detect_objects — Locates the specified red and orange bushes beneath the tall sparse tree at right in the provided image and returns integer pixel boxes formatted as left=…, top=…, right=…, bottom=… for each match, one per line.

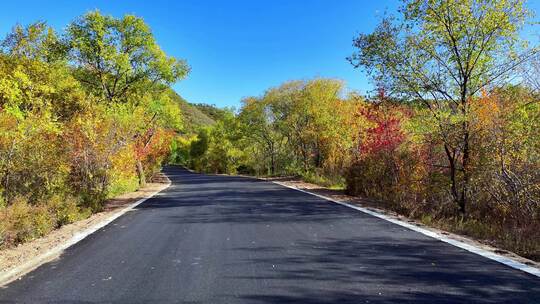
left=346, top=94, right=540, bottom=259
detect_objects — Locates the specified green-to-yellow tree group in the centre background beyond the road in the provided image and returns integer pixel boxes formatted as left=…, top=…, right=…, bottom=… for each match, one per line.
left=178, top=79, right=358, bottom=180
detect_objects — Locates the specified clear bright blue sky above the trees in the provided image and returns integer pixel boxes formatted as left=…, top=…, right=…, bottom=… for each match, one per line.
left=0, top=0, right=540, bottom=107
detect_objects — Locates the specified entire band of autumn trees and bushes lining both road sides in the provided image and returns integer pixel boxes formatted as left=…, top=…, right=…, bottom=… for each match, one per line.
left=0, top=0, right=540, bottom=258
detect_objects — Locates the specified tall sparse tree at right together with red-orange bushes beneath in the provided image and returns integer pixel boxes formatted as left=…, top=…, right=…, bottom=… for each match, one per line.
left=347, top=0, right=540, bottom=259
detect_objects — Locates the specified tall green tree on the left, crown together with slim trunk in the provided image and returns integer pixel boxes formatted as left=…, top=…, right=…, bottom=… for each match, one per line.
left=67, top=11, right=189, bottom=185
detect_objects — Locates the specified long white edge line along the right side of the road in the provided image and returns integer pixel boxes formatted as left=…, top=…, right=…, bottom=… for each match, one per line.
left=272, top=181, right=540, bottom=278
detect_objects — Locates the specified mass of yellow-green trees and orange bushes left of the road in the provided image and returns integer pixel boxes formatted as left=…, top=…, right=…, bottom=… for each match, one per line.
left=0, top=11, right=189, bottom=247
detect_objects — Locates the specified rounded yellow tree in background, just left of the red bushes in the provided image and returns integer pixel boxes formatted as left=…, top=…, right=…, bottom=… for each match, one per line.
left=263, top=78, right=355, bottom=173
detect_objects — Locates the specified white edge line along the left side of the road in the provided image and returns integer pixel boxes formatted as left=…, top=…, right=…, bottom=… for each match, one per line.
left=0, top=181, right=171, bottom=287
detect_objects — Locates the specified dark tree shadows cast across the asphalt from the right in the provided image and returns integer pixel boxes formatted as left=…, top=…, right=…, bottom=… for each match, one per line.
left=140, top=167, right=540, bottom=304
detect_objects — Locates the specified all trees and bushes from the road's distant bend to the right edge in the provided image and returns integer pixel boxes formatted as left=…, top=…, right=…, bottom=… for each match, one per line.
left=172, top=0, right=540, bottom=260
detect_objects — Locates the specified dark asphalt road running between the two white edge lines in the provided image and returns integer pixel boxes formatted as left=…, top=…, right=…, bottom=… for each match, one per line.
left=0, top=167, right=540, bottom=304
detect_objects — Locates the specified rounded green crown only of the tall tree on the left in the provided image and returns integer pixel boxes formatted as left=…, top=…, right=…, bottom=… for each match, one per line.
left=67, top=11, right=189, bottom=102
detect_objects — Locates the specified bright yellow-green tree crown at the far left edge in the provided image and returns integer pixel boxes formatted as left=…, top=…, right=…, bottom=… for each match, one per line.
left=0, top=22, right=84, bottom=121
